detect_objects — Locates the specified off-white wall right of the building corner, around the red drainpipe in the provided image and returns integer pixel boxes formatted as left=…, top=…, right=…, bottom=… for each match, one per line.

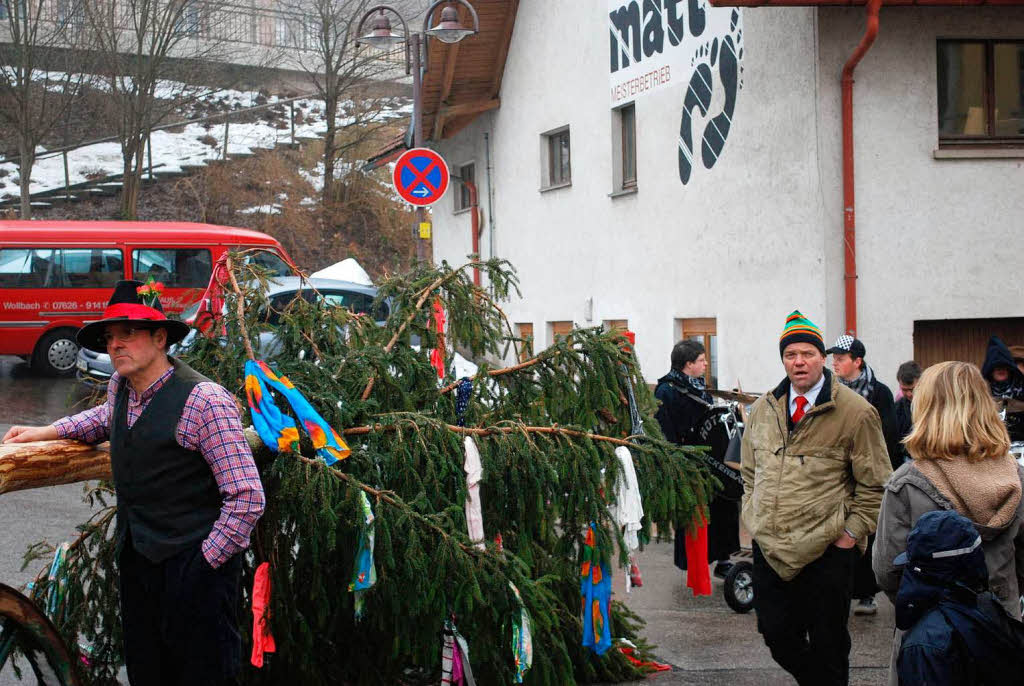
left=819, top=7, right=1024, bottom=386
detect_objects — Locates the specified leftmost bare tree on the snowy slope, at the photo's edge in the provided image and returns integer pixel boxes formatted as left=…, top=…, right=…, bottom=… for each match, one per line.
left=0, top=0, right=87, bottom=219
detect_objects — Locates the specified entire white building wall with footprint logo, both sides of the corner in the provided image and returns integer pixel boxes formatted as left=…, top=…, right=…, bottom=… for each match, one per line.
left=434, top=2, right=1024, bottom=391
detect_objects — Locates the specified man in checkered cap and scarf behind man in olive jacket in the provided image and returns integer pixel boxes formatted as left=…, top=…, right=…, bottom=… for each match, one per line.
left=825, top=334, right=903, bottom=614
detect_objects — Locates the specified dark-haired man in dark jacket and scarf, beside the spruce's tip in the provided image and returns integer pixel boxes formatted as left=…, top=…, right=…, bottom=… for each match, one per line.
left=654, top=340, right=739, bottom=577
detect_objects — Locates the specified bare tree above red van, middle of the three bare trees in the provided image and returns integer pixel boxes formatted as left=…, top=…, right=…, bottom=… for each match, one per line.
left=82, top=0, right=270, bottom=219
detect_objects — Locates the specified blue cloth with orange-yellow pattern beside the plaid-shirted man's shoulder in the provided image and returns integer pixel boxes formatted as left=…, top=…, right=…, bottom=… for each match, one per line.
left=246, top=359, right=351, bottom=467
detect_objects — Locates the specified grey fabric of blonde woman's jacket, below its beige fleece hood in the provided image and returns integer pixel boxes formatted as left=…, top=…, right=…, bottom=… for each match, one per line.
left=871, top=462, right=1024, bottom=618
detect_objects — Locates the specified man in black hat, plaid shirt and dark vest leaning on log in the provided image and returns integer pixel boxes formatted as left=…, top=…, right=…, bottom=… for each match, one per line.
left=3, top=280, right=265, bottom=686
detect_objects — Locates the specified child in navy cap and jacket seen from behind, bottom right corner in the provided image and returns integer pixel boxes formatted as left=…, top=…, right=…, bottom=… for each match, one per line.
left=893, top=510, right=1024, bottom=686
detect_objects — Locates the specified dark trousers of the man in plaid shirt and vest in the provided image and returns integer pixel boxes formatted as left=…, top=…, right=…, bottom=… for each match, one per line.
left=119, top=538, right=242, bottom=686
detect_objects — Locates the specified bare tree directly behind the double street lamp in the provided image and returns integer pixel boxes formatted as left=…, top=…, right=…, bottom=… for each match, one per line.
left=285, top=0, right=411, bottom=205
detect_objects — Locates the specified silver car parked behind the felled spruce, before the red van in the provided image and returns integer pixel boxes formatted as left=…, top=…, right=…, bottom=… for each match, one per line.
left=76, top=276, right=390, bottom=386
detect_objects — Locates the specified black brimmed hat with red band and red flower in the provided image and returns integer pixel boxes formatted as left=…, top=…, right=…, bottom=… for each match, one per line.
left=76, top=280, right=188, bottom=352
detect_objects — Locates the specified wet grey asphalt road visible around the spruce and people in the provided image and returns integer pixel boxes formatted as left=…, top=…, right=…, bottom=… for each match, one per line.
left=0, top=356, right=894, bottom=686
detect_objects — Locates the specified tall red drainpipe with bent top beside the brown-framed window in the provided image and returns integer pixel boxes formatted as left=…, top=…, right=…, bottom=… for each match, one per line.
left=842, top=0, right=882, bottom=336
